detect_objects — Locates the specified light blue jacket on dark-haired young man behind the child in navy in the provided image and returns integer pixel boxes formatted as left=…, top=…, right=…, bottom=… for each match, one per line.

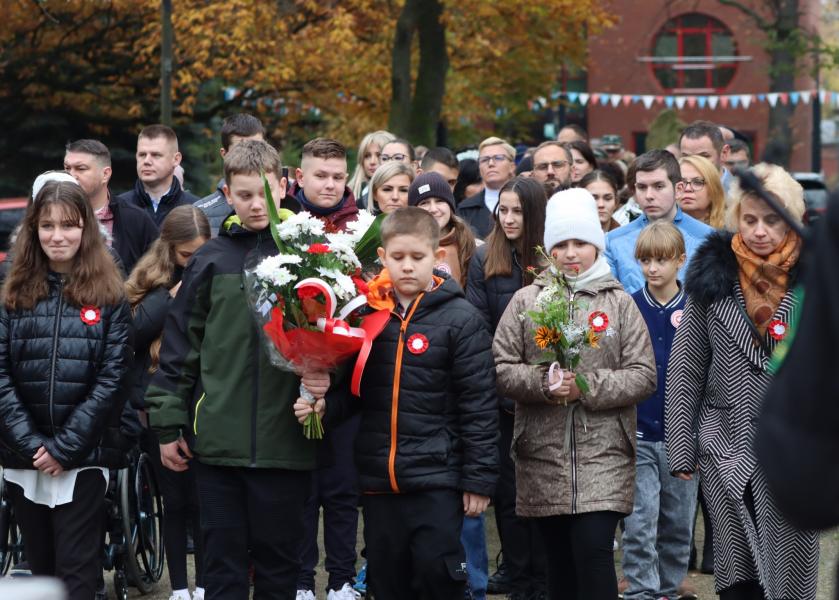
left=606, top=206, right=714, bottom=294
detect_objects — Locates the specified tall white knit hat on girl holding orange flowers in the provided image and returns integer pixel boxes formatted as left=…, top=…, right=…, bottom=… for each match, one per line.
left=545, top=188, right=606, bottom=252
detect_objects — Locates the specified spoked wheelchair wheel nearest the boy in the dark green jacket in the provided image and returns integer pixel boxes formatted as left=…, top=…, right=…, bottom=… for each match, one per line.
left=118, top=453, right=163, bottom=594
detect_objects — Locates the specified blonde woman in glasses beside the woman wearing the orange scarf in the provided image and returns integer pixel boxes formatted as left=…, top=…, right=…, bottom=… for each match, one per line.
left=679, top=155, right=725, bottom=229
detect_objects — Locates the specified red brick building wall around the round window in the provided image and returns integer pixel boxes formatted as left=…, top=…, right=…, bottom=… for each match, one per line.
left=587, top=0, right=818, bottom=171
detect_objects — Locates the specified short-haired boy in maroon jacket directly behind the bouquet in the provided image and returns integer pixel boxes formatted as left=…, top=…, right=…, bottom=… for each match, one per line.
left=283, top=138, right=358, bottom=230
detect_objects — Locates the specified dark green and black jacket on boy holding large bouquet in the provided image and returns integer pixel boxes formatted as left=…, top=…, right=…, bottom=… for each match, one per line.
left=146, top=217, right=317, bottom=470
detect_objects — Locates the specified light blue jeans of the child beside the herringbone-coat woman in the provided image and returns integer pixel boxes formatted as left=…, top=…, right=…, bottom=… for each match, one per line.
left=623, top=440, right=698, bottom=600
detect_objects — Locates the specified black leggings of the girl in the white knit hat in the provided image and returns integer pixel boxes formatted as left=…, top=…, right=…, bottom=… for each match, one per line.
left=536, top=511, right=622, bottom=600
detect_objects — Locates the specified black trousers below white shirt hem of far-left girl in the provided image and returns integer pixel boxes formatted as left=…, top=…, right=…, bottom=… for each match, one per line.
left=6, top=470, right=105, bottom=600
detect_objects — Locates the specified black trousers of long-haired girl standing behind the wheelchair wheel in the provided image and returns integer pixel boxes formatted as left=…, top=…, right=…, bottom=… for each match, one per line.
left=148, top=430, right=204, bottom=590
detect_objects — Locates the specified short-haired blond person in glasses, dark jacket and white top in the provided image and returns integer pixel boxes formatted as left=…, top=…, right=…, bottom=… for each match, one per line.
left=457, top=137, right=516, bottom=239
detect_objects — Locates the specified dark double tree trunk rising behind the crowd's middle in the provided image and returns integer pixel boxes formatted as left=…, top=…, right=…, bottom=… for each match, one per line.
left=389, top=0, right=449, bottom=146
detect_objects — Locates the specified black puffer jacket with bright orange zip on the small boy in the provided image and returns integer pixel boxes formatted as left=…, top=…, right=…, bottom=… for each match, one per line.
left=327, top=279, right=498, bottom=496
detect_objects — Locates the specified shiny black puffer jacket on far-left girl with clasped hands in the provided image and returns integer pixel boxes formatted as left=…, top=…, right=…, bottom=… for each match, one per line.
left=0, top=274, right=132, bottom=469
